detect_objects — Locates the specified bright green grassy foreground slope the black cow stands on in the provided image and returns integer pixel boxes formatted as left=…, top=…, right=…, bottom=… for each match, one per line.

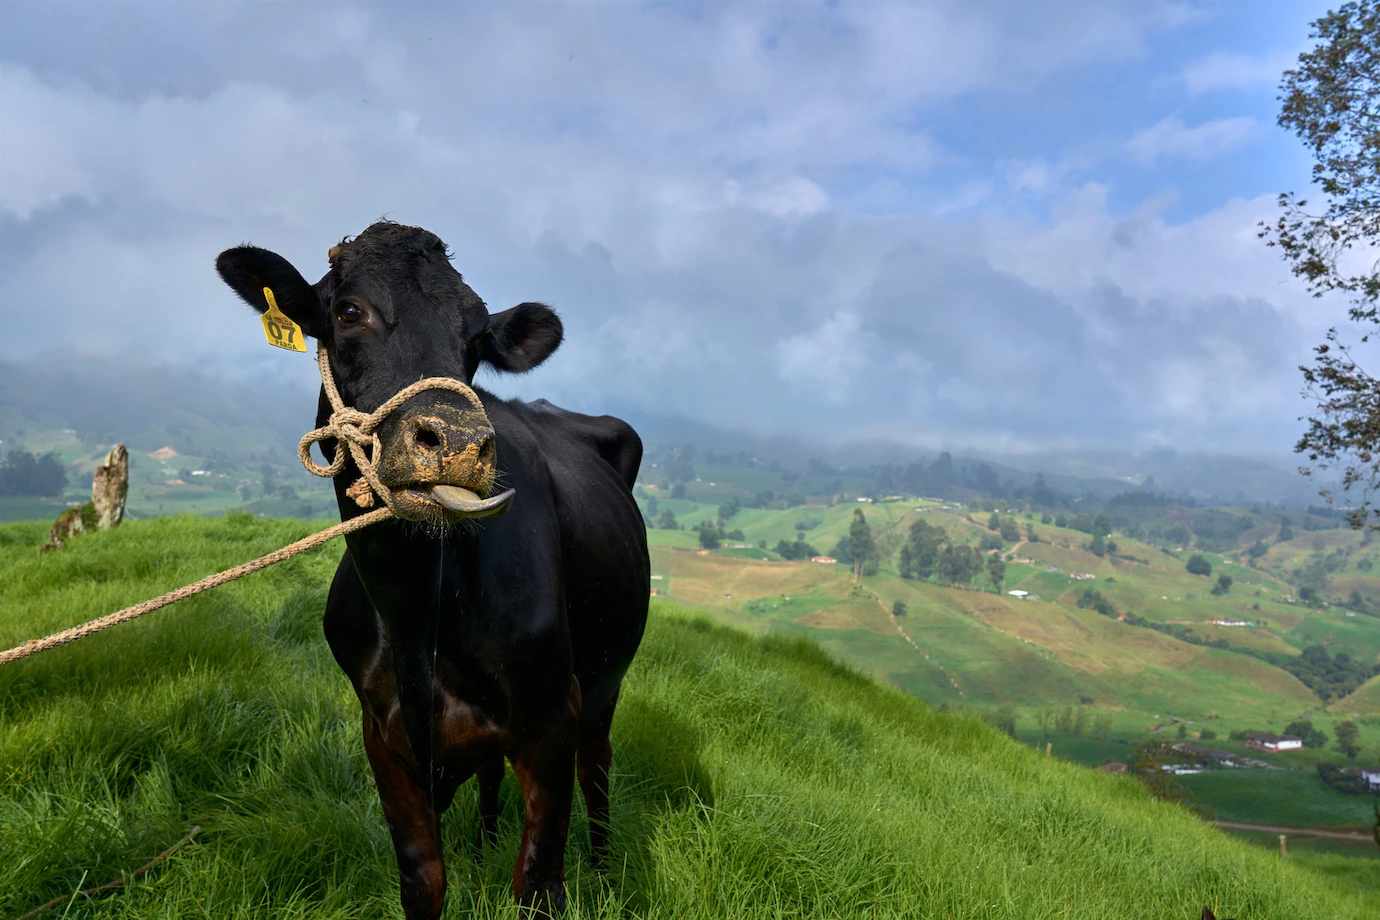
left=0, top=517, right=1373, bottom=920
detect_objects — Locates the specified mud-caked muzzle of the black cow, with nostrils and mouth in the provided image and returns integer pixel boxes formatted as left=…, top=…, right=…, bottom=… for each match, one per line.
left=378, top=393, right=498, bottom=520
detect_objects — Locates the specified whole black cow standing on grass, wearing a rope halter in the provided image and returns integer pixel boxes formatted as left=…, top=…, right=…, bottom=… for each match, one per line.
left=217, top=222, right=651, bottom=919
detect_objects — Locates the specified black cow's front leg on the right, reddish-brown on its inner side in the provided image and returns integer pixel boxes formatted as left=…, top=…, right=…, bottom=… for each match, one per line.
left=511, top=677, right=580, bottom=914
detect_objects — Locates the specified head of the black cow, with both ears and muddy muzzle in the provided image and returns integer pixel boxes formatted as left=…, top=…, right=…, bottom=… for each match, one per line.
left=215, top=222, right=562, bottom=521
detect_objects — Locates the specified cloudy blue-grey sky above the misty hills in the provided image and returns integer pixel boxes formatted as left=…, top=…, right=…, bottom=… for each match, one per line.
left=0, top=0, right=1346, bottom=457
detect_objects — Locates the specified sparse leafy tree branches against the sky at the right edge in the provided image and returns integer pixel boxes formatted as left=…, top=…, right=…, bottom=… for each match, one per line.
left=1260, top=0, right=1380, bottom=527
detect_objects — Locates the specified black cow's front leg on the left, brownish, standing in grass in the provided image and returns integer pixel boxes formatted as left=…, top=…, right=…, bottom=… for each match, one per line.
left=364, top=710, right=446, bottom=920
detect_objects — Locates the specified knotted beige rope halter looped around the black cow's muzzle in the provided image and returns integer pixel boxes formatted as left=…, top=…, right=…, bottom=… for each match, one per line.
left=297, top=345, right=484, bottom=512
